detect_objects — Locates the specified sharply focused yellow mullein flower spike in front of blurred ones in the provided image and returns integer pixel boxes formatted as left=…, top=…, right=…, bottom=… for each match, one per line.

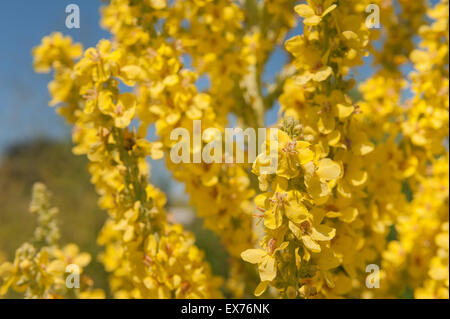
left=246, top=1, right=374, bottom=298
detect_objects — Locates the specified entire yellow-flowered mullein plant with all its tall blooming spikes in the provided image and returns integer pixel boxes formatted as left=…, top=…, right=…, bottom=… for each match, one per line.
left=1, top=0, right=449, bottom=298
